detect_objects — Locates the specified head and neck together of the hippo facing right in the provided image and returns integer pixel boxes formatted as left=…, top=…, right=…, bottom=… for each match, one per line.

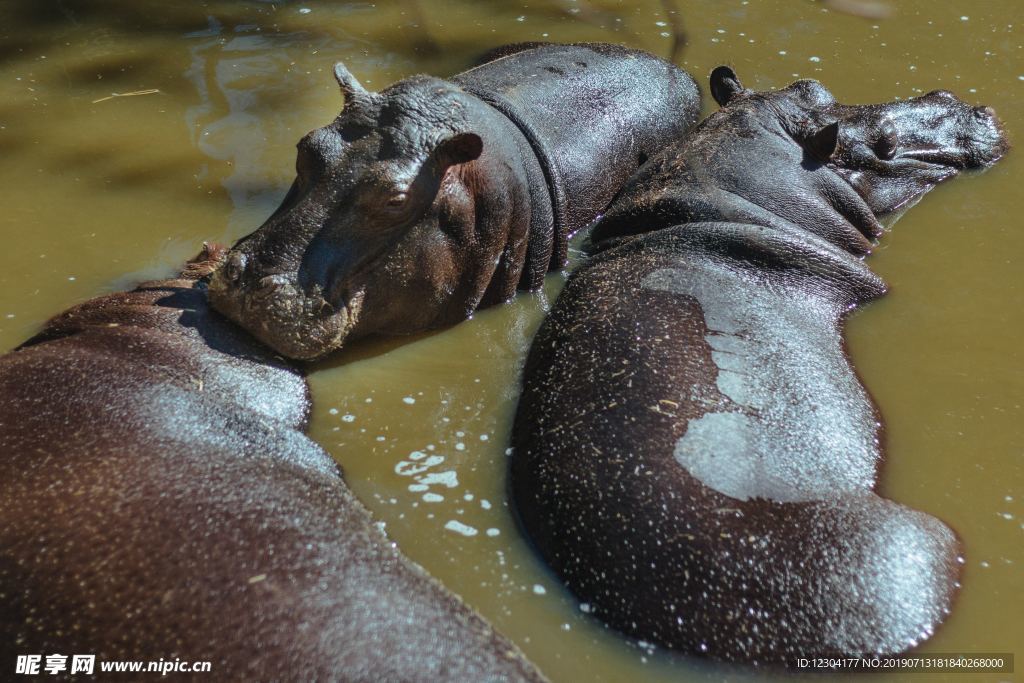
left=591, top=67, right=1009, bottom=255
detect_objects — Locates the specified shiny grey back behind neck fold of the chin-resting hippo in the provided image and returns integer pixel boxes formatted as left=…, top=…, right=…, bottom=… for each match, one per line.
left=452, top=43, right=700, bottom=267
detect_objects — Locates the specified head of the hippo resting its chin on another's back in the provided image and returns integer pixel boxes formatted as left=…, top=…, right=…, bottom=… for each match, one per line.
left=209, top=63, right=512, bottom=359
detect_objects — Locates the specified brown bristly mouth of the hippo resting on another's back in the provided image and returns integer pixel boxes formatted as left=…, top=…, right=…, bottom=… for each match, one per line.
left=209, top=268, right=365, bottom=360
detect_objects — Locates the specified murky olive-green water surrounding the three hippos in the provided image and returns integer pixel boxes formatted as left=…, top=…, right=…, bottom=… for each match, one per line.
left=0, top=0, right=1024, bottom=681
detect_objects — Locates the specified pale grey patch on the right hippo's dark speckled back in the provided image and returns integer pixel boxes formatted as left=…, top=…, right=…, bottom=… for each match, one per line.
left=641, top=261, right=879, bottom=502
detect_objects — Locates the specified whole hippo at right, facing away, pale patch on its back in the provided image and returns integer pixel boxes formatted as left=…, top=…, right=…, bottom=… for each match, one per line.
left=510, top=67, right=1008, bottom=666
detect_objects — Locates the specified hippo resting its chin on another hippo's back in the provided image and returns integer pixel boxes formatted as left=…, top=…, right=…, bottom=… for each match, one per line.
left=210, top=43, right=700, bottom=360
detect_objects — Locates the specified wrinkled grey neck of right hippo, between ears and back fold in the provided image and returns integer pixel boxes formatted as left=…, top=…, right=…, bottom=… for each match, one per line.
left=591, top=105, right=882, bottom=257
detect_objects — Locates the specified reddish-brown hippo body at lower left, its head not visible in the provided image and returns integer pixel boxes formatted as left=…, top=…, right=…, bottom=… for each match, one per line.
left=0, top=244, right=544, bottom=681
